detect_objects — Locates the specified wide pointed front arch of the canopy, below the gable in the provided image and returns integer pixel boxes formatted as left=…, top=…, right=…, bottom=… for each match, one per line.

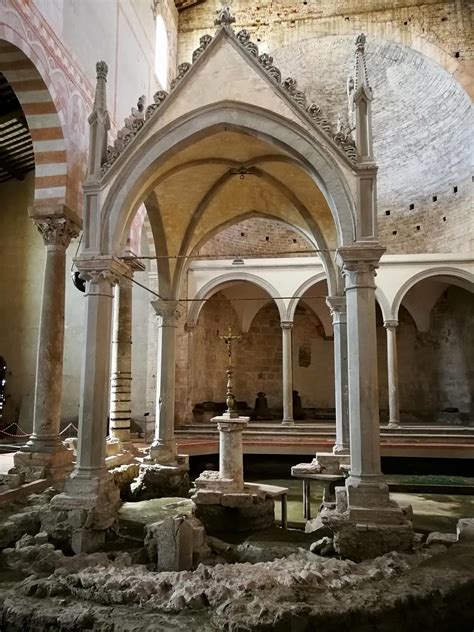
left=101, top=101, right=356, bottom=254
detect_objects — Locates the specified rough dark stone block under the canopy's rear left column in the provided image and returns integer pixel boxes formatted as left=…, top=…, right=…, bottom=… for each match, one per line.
left=130, top=454, right=190, bottom=501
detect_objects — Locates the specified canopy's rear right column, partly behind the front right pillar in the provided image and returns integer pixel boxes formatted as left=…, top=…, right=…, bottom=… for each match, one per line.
left=326, top=296, right=350, bottom=454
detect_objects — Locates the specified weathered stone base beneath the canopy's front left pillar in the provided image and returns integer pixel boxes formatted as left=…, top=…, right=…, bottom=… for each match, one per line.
left=41, top=470, right=121, bottom=553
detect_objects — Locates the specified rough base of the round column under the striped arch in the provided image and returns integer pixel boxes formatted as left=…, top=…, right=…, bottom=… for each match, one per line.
left=8, top=444, right=74, bottom=490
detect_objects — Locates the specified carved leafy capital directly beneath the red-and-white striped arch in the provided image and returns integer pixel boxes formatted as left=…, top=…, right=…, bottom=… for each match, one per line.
left=28, top=205, right=82, bottom=250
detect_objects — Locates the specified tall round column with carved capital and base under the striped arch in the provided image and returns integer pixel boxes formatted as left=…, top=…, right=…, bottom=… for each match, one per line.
left=15, top=206, right=81, bottom=478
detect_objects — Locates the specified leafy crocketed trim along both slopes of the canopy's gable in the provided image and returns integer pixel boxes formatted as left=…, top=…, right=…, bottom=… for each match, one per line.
left=101, top=6, right=365, bottom=175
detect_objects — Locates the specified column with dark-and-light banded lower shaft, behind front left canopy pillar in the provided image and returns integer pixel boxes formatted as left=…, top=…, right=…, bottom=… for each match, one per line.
left=109, top=261, right=144, bottom=442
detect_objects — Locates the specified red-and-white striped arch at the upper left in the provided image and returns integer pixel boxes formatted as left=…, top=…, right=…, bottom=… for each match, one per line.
left=0, top=38, right=67, bottom=206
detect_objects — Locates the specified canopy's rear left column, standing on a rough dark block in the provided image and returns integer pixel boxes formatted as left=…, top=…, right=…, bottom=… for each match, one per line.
left=150, top=299, right=181, bottom=465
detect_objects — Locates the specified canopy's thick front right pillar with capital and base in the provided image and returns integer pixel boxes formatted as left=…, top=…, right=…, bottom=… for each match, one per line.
left=337, top=244, right=397, bottom=522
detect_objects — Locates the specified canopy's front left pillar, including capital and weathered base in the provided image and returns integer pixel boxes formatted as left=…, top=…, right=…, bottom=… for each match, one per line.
left=49, top=256, right=127, bottom=553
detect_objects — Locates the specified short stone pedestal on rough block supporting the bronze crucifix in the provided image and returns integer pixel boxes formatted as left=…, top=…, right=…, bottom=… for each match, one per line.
left=191, top=413, right=275, bottom=533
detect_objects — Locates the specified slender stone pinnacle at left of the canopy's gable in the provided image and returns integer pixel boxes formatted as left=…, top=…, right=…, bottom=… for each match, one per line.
left=87, top=61, right=110, bottom=183
